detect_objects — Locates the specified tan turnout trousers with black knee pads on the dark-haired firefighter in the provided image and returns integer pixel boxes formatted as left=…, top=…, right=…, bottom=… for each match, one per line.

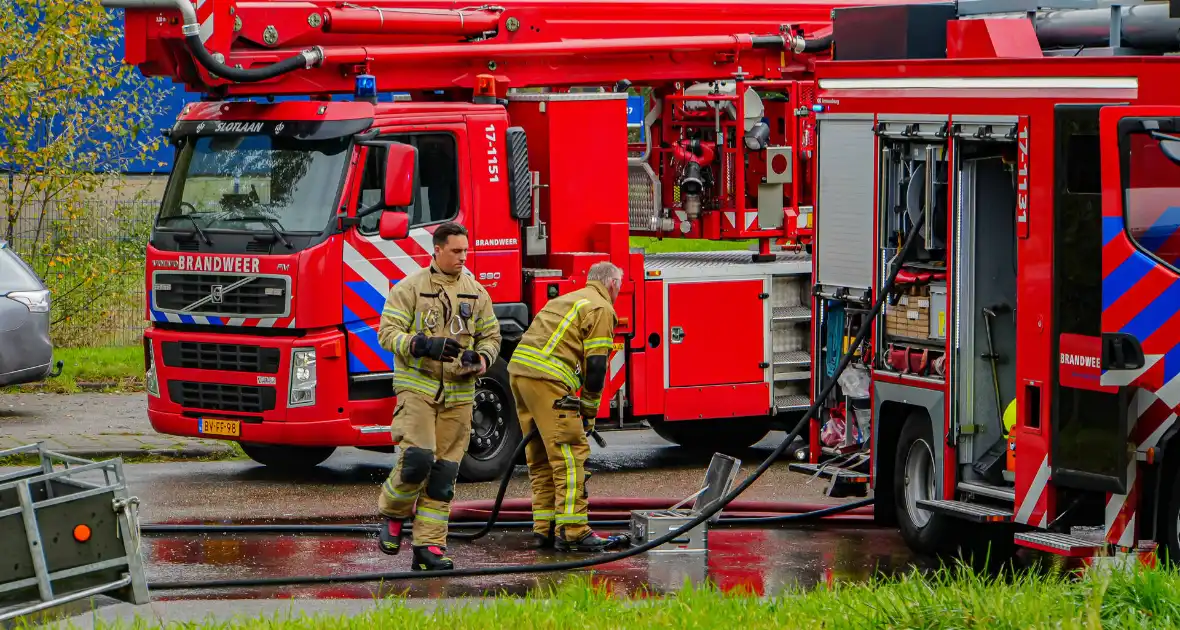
left=378, top=392, right=472, bottom=547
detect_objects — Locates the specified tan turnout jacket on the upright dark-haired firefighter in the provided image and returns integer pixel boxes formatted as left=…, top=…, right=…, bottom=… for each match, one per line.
left=378, top=262, right=500, bottom=408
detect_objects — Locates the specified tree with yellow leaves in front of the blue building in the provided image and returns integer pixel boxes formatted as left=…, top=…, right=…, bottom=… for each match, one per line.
left=0, top=0, right=162, bottom=346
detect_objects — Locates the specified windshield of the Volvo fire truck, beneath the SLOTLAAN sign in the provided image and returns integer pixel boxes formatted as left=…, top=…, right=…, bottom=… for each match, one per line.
left=158, top=134, right=348, bottom=234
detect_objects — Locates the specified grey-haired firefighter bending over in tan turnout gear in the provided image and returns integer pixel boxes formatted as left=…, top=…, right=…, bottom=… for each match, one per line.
left=509, top=262, right=623, bottom=551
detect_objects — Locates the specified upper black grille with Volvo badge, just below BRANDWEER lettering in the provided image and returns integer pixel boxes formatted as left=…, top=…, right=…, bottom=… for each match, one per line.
left=151, top=273, right=290, bottom=317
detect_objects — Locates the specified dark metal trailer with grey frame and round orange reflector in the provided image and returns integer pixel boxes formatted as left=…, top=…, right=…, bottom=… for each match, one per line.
left=0, top=444, right=149, bottom=621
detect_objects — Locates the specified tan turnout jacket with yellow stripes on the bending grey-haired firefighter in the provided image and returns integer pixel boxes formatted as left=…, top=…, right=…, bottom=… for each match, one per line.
left=509, top=281, right=618, bottom=405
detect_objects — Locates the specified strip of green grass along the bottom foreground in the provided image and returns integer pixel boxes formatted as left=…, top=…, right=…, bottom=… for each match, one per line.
left=39, top=567, right=1180, bottom=630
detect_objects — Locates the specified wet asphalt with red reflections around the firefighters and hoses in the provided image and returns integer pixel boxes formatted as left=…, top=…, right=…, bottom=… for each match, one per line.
left=4, top=431, right=925, bottom=622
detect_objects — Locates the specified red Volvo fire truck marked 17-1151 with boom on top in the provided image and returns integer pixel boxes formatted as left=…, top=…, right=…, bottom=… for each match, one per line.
left=104, top=0, right=868, bottom=480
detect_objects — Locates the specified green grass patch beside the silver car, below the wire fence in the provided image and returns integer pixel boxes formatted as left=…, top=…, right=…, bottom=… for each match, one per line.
left=0, top=346, right=144, bottom=394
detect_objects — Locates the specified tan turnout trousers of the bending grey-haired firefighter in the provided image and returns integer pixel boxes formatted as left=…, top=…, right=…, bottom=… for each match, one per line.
left=510, top=375, right=590, bottom=540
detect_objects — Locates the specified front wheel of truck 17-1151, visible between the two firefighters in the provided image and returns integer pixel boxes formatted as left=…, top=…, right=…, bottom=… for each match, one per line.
left=459, top=359, right=522, bottom=481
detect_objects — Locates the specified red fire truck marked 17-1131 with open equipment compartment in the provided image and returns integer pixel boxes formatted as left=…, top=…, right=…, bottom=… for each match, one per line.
left=793, top=0, right=1180, bottom=559
